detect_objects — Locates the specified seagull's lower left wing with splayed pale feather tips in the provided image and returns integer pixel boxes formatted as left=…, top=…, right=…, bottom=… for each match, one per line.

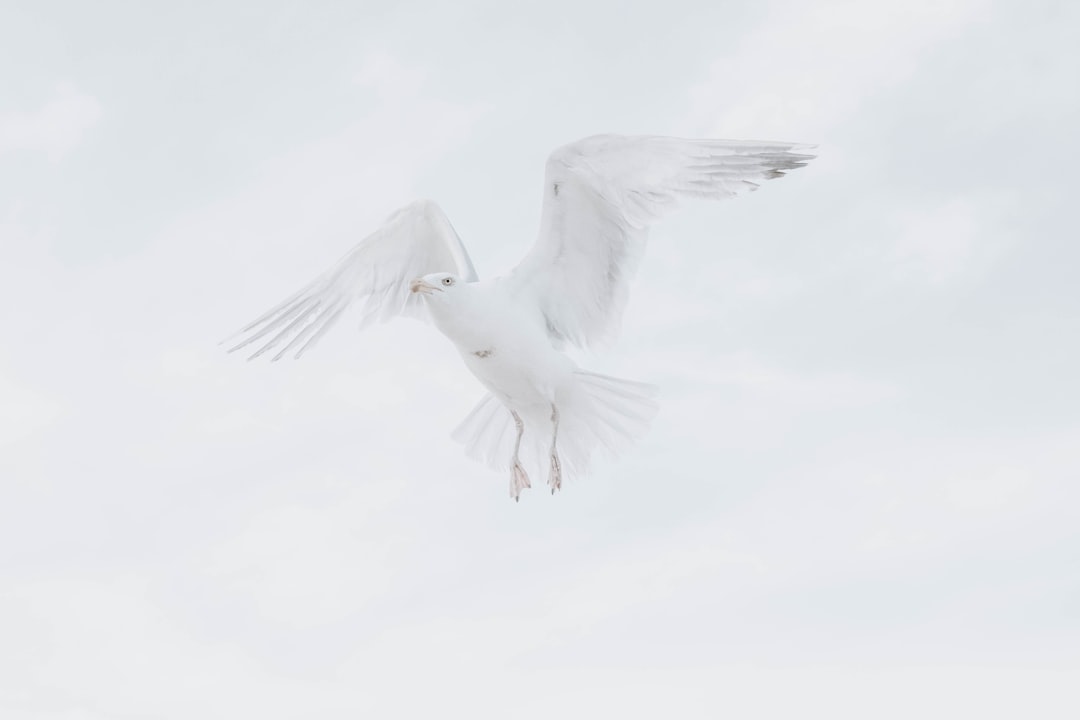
left=229, top=200, right=476, bottom=361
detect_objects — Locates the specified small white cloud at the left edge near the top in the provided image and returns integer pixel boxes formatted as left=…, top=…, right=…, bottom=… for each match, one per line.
left=0, top=85, right=102, bottom=163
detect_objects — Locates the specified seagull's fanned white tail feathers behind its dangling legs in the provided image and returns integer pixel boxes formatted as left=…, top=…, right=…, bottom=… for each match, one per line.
left=454, top=370, right=659, bottom=483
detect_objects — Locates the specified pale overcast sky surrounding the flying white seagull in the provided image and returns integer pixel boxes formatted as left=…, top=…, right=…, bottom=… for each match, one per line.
left=0, top=0, right=1080, bottom=720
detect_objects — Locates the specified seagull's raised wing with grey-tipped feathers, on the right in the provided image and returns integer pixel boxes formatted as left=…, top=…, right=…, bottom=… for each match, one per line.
left=513, top=135, right=813, bottom=347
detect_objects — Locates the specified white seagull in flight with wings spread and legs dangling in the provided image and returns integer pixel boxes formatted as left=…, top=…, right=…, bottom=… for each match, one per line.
left=229, top=135, right=814, bottom=501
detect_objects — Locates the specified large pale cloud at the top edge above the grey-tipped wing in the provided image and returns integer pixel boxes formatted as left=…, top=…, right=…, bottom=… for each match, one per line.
left=689, top=0, right=985, bottom=140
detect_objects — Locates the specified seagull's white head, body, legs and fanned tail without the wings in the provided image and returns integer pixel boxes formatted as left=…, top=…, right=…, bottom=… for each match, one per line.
left=414, top=273, right=656, bottom=500
